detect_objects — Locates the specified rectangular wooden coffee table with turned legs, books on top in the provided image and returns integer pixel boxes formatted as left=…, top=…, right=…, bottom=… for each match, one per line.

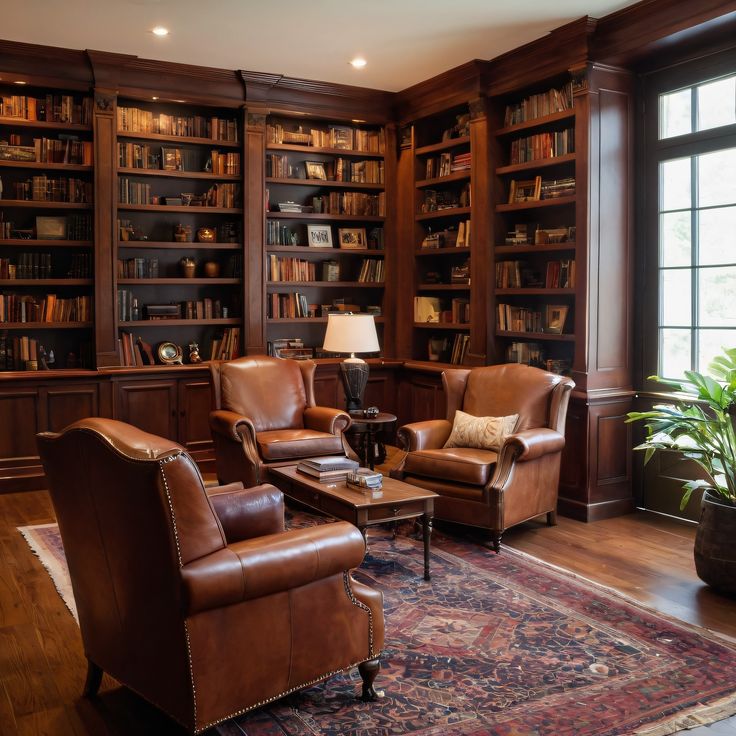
left=268, top=465, right=437, bottom=580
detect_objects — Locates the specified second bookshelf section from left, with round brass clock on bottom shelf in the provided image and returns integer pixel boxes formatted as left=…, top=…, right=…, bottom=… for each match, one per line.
left=115, top=99, right=244, bottom=366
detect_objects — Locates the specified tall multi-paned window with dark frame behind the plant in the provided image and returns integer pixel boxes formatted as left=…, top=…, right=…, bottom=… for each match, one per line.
left=644, top=60, right=736, bottom=378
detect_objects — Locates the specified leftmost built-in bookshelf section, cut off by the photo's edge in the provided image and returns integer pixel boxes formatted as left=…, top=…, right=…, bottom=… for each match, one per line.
left=0, top=85, right=94, bottom=371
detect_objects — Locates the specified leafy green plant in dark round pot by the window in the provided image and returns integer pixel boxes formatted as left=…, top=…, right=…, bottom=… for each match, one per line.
left=626, top=348, right=736, bottom=593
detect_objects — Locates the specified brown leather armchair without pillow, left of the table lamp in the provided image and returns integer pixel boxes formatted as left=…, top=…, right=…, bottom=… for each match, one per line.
left=210, top=355, right=353, bottom=486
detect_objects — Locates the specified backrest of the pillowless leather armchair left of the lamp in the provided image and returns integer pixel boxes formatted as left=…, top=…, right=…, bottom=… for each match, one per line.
left=211, top=355, right=315, bottom=432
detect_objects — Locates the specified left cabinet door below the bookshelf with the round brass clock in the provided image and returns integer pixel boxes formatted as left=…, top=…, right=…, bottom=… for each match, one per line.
left=113, top=378, right=178, bottom=440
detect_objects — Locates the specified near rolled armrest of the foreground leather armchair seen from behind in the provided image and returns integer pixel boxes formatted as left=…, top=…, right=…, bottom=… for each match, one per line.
left=181, top=521, right=365, bottom=616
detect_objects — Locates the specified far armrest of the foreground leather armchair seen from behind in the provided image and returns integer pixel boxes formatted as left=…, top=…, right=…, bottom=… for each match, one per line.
left=206, top=483, right=284, bottom=544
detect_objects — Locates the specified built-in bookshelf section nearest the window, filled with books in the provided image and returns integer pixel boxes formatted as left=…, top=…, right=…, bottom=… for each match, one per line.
left=492, top=81, right=578, bottom=373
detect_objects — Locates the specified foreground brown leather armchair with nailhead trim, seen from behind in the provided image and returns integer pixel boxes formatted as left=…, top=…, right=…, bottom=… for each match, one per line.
left=37, top=419, right=383, bottom=733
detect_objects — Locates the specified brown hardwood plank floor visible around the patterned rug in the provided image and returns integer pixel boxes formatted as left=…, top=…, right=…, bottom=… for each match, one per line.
left=0, top=491, right=736, bottom=736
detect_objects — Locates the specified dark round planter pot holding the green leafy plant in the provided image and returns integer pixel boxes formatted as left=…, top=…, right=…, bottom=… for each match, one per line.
left=695, top=492, right=736, bottom=593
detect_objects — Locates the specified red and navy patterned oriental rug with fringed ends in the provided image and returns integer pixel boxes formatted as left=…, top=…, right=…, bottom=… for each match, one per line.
left=21, top=515, right=736, bottom=736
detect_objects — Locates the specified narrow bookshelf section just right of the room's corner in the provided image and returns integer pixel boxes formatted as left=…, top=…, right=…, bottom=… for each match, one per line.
left=411, top=106, right=473, bottom=364
